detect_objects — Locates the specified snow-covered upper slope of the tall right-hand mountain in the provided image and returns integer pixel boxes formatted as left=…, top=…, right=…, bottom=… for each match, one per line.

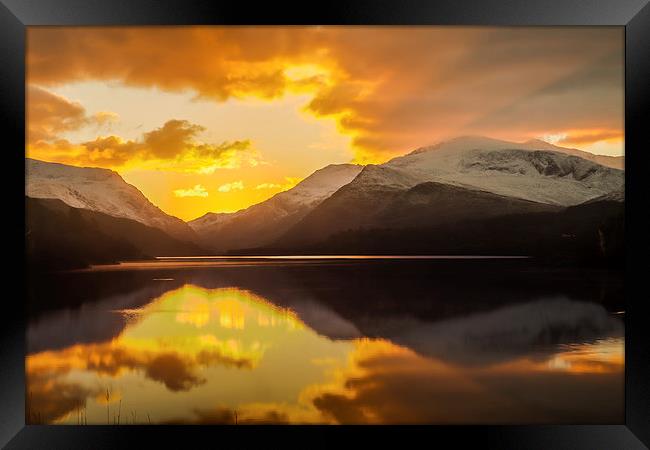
left=380, top=136, right=624, bottom=206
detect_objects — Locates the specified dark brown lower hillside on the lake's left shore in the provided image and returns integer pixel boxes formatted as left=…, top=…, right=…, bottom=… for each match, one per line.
left=25, top=197, right=204, bottom=269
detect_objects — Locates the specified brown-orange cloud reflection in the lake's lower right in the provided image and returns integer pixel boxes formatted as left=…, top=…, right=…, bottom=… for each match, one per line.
left=311, top=341, right=624, bottom=424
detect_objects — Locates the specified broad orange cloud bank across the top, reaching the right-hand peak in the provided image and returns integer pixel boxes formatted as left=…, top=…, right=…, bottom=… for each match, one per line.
left=27, top=27, right=624, bottom=162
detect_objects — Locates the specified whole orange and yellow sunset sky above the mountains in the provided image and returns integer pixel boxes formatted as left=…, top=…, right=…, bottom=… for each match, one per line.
left=26, top=26, right=624, bottom=220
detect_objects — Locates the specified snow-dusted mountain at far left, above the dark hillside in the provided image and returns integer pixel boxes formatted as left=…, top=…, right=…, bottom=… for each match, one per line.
left=25, top=158, right=197, bottom=242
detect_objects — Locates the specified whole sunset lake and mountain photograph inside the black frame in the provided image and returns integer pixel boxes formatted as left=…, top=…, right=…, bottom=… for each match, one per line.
left=25, top=26, right=625, bottom=425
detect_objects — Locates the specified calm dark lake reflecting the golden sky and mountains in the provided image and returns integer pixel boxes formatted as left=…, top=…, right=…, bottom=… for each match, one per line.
left=26, top=259, right=624, bottom=424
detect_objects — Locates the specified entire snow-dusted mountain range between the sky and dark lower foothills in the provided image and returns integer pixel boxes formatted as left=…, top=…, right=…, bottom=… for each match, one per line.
left=25, top=136, right=624, bottom=260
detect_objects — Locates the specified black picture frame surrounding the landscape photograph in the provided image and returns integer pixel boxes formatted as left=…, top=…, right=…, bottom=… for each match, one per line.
left=0, top=0, right=650, bottom=449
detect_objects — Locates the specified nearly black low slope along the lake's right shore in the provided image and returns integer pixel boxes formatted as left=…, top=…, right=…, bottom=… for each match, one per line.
left=260, top=197, right=625, bottom=268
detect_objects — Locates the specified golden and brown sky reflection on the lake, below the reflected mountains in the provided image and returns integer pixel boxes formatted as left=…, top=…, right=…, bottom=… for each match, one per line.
left=26, top=284, right=624, bottom=424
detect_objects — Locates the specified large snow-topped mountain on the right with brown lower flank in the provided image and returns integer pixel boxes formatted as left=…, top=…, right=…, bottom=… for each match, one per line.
left=260, top=136, right=624, bottom=251
